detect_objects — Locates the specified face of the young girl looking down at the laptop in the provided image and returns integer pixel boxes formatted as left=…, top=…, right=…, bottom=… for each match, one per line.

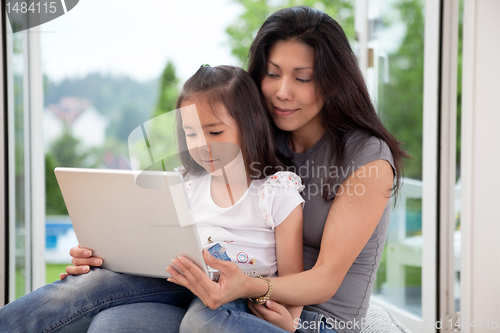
left=181, top=100, right=241, bottom=173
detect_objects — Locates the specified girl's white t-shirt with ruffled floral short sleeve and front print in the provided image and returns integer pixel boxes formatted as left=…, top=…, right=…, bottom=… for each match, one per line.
left=185, top=171, right=304, bottom=275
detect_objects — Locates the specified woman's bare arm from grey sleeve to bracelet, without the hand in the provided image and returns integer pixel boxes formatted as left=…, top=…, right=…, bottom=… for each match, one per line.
left=264, top=160, right=394, bottom=305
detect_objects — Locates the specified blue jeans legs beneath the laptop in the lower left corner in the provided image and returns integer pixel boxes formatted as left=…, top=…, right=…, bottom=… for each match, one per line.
left=0, top=268, right=193, bottom=333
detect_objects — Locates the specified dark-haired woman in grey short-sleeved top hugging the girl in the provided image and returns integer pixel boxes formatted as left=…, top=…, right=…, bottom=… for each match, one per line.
left=169, top=7, right=406, bottom=332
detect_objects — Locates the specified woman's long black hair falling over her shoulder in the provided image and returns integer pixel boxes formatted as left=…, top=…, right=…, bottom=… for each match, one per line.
left=248, top=6, right=409, bottom=201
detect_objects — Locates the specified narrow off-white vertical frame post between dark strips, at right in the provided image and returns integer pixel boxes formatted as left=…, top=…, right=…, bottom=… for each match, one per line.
left=438, top=0, right=460, bottom=333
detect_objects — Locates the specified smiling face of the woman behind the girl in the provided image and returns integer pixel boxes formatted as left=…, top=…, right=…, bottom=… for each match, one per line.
left=261, top=40, right=323, bottom=133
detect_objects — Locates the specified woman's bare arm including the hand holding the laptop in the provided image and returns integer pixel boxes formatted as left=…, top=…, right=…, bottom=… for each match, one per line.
left=168, top=160, right=394, bottom=309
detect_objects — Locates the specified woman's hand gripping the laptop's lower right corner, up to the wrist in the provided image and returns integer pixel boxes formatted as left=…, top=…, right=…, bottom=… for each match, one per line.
left=166, top=250, right=251, bottom=310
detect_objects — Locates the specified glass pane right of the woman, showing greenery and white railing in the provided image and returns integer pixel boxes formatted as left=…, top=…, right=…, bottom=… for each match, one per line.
left=367, top=0, right=424, bottom=316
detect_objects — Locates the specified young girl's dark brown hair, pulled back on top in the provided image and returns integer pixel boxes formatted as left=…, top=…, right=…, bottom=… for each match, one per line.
left=176, top=65, right=284, bottom=179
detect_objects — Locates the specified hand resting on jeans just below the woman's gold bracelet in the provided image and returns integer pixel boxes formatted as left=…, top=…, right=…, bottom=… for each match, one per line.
left=248, top=300, right=296, bottom=332
